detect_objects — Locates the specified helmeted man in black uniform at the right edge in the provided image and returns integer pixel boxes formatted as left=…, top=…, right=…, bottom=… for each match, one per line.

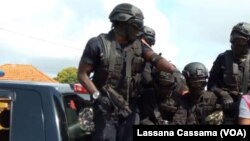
left=208, top=22, right=250, bottom=124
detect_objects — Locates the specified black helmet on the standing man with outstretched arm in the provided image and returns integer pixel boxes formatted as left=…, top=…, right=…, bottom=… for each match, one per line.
left=109, top=3, right=144, bottom=29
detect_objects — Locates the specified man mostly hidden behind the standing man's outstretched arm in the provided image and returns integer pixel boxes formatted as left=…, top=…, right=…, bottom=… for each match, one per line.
left=138, top=26, right=157, bottom=125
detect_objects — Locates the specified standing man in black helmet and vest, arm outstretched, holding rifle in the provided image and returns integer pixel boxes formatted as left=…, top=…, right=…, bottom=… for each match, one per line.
left=78, top=3, right=175, bottom=141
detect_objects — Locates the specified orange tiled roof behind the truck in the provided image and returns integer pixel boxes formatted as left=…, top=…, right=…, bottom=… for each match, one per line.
left=0, top=64, right=58, bottom=83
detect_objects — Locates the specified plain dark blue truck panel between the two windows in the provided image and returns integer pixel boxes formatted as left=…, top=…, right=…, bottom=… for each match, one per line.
left=10, top=89, right=45, bottom=141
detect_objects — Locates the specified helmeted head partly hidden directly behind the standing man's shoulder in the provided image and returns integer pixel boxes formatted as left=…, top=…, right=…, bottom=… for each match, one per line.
left=143, top=26, right=155, bottom=46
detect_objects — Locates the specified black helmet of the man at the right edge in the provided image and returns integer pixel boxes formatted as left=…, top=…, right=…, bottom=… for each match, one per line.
left=230, top=22, right=250, bottom=43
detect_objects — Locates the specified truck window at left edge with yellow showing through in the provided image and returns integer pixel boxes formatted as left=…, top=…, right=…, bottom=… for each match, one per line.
left=0, top=90, right=13, bottom=141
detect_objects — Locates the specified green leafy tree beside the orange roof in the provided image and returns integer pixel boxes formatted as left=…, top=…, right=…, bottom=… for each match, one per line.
left=55, top=67, right=78, bottom=84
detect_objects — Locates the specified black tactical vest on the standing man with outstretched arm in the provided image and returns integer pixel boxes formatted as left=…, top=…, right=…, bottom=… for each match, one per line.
left=93, top=32, right=145, bottom=98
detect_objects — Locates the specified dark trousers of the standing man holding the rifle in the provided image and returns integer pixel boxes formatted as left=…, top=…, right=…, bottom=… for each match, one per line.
left=92, top=96, right=139, bottom=141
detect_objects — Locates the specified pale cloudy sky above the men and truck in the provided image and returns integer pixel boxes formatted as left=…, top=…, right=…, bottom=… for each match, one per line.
left=0, top=0, right=250, bottom=77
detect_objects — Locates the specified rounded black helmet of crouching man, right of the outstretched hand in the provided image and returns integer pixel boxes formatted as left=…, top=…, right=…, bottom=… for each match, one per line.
left=182, top=62, right=208, bottom=81
